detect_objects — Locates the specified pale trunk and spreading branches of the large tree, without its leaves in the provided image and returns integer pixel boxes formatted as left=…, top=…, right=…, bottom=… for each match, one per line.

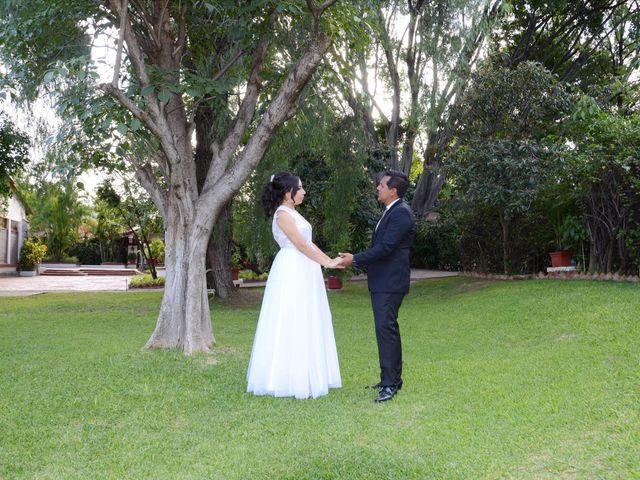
left=100, top=0, right=336, bottom=354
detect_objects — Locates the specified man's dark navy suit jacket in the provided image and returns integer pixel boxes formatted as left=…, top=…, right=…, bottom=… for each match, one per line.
left=353, top=200, right=416, bottom=293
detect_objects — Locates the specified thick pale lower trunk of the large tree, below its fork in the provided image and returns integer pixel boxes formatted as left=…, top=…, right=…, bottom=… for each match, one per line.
left=145, top=204, right=215, bottom=355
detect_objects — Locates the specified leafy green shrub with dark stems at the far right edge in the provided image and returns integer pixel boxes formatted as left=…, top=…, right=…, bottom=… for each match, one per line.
left=564, top=109, right=640, bottom=271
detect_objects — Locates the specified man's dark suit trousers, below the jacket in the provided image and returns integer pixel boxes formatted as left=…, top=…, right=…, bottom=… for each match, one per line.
left=371, top=292, right=405, bottom=387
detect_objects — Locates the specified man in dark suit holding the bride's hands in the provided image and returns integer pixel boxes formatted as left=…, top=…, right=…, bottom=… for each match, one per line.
left=340, top=170, right=415, bottom=402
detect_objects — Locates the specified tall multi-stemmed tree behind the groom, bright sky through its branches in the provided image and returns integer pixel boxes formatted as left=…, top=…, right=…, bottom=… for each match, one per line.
left=337, top=0, right=502, bottom=216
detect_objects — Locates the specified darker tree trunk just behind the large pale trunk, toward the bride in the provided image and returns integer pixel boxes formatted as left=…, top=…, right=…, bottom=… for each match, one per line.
left=207, top=202, right=236, bottom=298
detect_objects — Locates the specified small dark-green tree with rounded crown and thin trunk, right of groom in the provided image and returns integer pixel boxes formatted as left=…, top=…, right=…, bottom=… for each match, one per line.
left=447, top=62, right=569, bottom=273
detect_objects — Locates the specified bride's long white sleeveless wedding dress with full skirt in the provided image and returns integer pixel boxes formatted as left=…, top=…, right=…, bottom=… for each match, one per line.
left=247, top=205, right=342, bottom=398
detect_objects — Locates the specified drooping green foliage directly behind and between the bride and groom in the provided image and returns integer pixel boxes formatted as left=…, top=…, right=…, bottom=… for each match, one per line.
left=233, top=101, right=380, bottom=271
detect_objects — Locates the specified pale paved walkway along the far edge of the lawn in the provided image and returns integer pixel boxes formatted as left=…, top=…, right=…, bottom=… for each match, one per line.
left=0, top=270, right=458, bottom=296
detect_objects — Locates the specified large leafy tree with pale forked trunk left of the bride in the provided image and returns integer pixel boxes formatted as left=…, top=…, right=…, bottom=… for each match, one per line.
left=0, top=0, right=349, bottom=354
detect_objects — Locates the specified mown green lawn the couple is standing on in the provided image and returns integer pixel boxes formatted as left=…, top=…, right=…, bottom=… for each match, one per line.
left=0, top=278, right=640, bottom=480
